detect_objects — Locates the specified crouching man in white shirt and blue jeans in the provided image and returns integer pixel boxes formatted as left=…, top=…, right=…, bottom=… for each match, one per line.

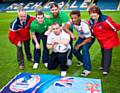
left=64, top=10, right=94, bottom=76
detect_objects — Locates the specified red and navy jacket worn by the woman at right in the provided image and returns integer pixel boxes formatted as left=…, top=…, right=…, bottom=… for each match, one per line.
left=89, top=15, right=120, bottom=49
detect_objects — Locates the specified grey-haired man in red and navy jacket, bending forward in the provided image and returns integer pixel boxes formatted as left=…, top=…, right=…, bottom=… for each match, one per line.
left=9, top=9, right=34, bottom=69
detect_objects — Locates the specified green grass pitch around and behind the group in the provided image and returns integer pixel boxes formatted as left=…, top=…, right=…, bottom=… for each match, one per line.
left=0, top=11, right=120, bottom=93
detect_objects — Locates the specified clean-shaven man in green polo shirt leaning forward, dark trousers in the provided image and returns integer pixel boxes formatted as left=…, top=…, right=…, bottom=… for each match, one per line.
left=30, top=11, right=51, bottom=69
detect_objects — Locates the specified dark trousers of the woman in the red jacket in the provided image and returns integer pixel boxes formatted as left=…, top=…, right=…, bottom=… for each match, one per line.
left=101, top=48, right=112, bottom=72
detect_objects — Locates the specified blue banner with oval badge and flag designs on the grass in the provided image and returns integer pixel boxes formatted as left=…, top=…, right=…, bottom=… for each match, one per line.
left=0, top=73, right=102, bottom=93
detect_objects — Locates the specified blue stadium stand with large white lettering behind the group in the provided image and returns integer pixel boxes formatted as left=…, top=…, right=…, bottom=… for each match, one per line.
left=0, top=0, right=120, bottom=12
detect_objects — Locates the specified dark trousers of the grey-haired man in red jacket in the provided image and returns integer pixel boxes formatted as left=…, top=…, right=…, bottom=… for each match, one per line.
left=17, top=40, right=32, bottom=66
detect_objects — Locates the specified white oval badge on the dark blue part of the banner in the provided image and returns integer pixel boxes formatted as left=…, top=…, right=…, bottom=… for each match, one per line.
left=9, top=75, right=40, bottom=92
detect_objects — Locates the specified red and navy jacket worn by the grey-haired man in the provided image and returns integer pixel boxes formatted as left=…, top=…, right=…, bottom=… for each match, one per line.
left=8, top=15, right=35, bottom=45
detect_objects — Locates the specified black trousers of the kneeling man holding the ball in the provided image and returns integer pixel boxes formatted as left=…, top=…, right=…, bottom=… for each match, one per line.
left=48, top=52, right=67, bottom=71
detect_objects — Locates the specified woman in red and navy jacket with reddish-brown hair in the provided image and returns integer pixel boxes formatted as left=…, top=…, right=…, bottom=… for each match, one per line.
left=89, top=6, right=120, bottom=75
